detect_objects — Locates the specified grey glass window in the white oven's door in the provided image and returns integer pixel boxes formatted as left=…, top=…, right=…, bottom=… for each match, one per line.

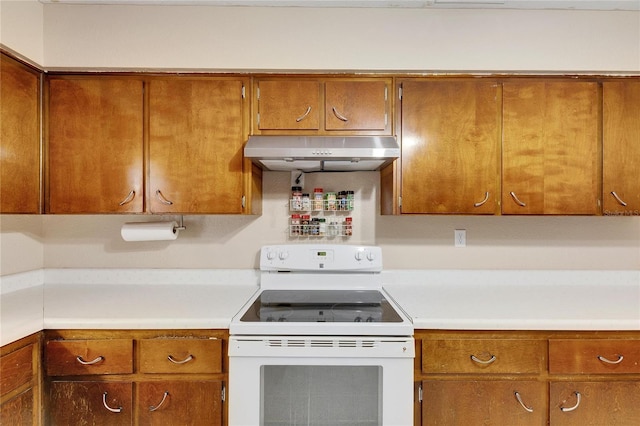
left=260, top=365, right=382, bottom=426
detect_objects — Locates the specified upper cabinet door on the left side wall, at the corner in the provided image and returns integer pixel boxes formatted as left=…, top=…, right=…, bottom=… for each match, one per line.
left=0, top=54, right=40, bottom=213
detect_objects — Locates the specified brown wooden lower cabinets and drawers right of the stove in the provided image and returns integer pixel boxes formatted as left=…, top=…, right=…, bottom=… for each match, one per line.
left=414, top=330, right=640, bottom=426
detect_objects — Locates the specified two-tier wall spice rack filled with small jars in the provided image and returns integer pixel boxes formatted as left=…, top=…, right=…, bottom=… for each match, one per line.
left=289, top=187, right=354, bottom=238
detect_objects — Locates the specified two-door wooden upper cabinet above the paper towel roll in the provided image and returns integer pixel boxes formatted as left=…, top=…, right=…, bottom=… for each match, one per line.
left=48, top=76, right=249, bottom=214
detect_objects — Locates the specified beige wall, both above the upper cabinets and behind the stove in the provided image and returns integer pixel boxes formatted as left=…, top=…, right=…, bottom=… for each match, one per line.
left=1, top=0, right=640, bottom=274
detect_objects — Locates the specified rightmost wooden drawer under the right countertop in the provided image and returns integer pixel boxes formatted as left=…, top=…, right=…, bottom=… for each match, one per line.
left=549, top=339, right=640, bottom=374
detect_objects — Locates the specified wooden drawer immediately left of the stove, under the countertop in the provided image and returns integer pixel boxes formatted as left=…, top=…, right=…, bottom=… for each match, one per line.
left=139, top=338, right=222, bottom=373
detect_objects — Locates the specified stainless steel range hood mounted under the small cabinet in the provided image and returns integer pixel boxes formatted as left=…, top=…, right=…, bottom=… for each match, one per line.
left=244, top=136, right=400, bottom=172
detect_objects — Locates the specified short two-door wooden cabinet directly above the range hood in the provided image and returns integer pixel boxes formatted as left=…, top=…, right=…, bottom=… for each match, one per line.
left=253, top=77, right=392, bottom=135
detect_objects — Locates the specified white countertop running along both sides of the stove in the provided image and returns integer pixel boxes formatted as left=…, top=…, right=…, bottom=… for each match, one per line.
left=0, top=269, right=640, bottom=345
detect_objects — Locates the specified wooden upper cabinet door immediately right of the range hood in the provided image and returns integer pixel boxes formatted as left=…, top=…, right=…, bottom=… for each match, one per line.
left=401, top=80, right=500, bottom=214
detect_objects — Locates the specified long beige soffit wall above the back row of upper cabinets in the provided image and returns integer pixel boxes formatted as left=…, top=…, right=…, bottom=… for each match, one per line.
left=44, top=4, right=640, bottom=71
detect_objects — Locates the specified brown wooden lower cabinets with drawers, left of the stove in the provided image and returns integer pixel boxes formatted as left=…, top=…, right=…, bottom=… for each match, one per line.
left=44, top=330, right=228, bottom=426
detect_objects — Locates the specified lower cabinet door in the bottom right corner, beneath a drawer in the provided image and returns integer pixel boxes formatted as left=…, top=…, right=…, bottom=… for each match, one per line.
left=549, top=380, right=640, bottom=426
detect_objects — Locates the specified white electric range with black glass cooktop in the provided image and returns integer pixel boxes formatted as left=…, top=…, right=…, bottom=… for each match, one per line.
left=228, top=244, right=415, bottom=426
